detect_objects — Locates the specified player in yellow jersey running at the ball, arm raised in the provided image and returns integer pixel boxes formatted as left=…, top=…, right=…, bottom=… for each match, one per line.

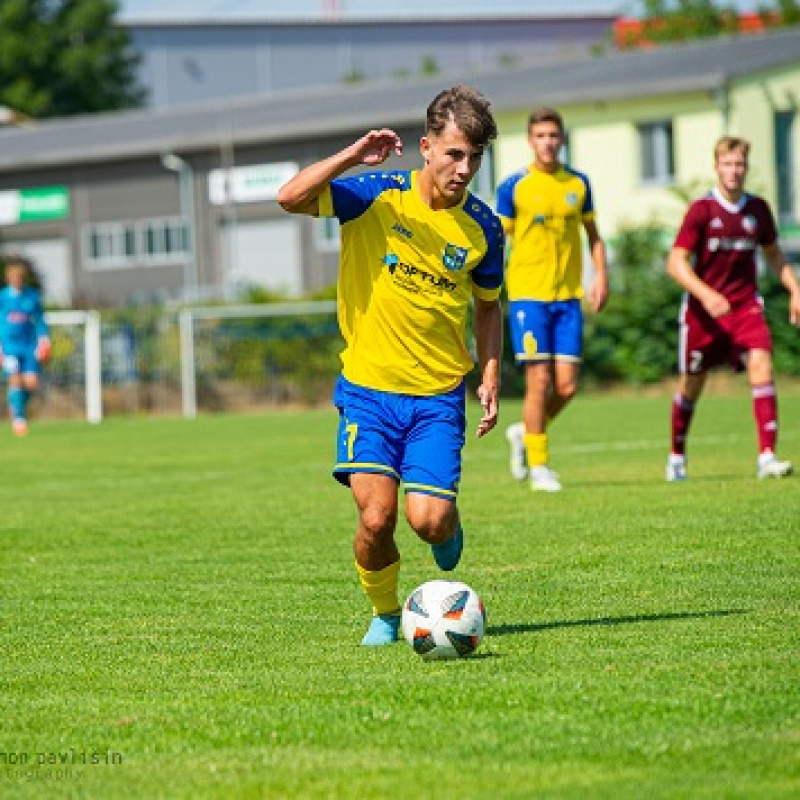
left=278, top=86, right=504, bottom=645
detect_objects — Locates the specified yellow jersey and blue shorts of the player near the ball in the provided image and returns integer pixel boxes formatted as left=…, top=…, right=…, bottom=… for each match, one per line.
left=319, top=171, right=504, bottom=499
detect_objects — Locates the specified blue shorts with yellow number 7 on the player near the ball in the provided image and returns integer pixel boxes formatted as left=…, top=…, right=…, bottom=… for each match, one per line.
left=333, top=376, right=466, bottom=500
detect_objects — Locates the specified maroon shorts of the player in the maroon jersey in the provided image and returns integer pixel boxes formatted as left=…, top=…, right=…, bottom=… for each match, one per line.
left=678, top=297, right=772, bottom=374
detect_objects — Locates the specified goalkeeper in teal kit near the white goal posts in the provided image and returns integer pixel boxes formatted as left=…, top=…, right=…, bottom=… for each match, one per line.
left=0, top=256, right=50, bottom=436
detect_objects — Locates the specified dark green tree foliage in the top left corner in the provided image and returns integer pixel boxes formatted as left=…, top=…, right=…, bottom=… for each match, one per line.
left=0, top=0, right=145, bottom=118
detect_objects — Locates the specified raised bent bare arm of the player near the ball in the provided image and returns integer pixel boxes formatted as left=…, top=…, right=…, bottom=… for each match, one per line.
left=277, top=128, right=403, bottom=216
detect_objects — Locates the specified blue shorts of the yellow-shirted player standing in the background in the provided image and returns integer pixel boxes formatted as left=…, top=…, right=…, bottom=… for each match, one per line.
left=508, top=300, right=583, bottom=364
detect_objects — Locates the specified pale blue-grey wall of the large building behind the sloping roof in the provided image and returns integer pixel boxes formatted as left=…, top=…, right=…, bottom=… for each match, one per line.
left=126, top=15, right=615, bottom=108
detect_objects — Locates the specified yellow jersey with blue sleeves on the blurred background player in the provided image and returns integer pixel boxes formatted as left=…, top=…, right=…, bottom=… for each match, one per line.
left=497, top=165, right=594, bottom=301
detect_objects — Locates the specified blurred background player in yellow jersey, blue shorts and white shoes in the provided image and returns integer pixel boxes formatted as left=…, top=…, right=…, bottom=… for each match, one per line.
left=497, top=108, right=608, bottom=492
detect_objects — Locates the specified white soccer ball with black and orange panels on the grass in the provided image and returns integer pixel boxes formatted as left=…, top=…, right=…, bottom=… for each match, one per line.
left=402, top=580, right=486, bottom=661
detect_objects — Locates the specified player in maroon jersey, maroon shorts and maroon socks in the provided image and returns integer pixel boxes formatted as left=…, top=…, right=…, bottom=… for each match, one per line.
left=667, top=136, right=800, bottom=481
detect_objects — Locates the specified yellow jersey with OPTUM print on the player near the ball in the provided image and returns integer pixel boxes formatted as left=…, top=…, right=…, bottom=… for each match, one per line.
left=319, top=170, right=504, bottom=396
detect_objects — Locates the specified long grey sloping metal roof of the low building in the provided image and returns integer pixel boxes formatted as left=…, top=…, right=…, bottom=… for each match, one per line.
left=0, top=27, right=800, bottom=172
